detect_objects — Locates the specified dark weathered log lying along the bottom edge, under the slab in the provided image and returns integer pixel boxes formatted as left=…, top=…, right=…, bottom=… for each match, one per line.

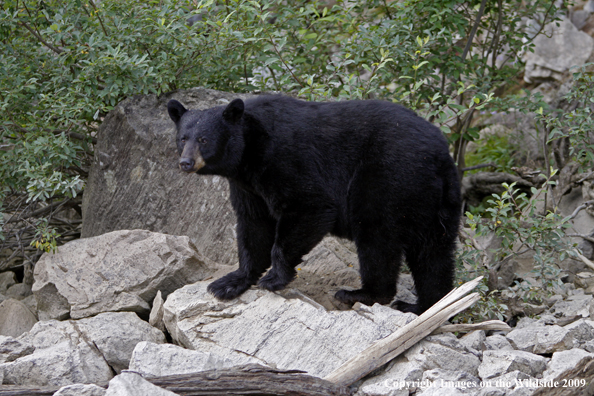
left=0, top=364, right=351, bottom=396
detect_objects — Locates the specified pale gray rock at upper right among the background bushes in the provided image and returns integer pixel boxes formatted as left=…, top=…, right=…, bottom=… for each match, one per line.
left=524, top=19, right=594, bottom=83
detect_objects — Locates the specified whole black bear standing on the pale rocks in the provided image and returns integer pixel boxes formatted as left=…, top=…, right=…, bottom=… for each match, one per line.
left=167, top=95, right=461, bottom=313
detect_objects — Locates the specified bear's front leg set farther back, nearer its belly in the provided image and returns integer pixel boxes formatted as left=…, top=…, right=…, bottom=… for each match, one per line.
left=258, top=211, right=334, bottom=291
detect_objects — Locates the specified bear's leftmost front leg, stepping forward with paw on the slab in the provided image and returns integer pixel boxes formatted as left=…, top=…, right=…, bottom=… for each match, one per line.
left=208, top=183, right=276, bottom=300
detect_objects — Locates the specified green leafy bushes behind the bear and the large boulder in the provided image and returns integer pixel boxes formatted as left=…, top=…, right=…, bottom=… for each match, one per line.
left=0, top=0, right=568, bottom=290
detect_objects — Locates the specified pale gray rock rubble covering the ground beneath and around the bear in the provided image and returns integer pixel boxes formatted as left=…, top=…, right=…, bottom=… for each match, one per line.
left=0, top=230, right=594, bottom=396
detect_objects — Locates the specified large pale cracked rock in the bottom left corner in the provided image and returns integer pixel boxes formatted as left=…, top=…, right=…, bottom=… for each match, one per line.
left=0, top=320, right=113, bottom=386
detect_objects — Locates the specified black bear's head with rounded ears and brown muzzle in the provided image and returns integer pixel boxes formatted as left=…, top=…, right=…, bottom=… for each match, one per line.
left=167, top=99, right=244, bottom=176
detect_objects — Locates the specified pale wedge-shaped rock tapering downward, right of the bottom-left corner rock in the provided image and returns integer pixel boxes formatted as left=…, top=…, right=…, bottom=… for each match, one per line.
left=76, top=312, right=165, bottom=373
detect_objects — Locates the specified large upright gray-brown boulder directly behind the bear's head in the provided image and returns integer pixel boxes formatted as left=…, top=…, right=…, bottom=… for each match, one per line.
left=82, top=88, right=251, bottom=264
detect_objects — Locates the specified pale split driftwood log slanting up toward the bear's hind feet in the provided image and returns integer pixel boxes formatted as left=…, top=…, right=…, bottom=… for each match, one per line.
left=324, top=276, right=483, bottom=386
